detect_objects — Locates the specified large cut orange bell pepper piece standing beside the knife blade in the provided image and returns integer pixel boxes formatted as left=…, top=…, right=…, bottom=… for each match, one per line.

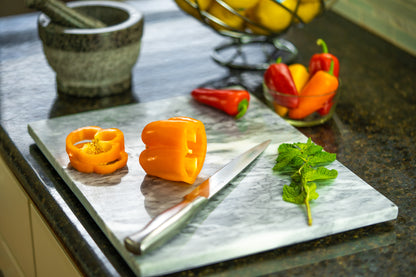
left=139, top=117, right=207, bottom=184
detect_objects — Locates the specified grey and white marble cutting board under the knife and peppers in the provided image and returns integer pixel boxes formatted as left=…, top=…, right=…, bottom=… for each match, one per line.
left=28, top=96, right=398, bottom=276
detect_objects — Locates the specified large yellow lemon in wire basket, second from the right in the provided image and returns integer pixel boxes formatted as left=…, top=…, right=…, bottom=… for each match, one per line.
left=247, top=0, right=297, bottom=34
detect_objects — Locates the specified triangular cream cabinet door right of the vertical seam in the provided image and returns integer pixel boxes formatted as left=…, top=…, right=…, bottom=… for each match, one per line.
left=30, top=204, right=81, bottom=277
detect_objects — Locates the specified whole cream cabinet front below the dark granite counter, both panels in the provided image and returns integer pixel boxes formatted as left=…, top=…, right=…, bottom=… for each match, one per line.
left=0, top=155, right=81, bottom=277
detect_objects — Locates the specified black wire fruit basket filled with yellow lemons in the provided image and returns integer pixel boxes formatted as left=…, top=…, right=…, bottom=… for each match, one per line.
left=175, top=0, right=329, bottom=70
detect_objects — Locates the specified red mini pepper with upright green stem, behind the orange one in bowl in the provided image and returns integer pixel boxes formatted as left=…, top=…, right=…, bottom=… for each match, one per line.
left=309, top=39, right=339, bottom=78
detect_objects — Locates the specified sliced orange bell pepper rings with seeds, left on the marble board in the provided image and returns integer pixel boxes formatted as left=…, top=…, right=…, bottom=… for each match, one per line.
left=66, top=126, right=128, bottom=174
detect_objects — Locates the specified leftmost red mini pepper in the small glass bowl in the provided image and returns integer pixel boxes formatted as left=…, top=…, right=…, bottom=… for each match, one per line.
left=264, top=58, right=299, bottom=109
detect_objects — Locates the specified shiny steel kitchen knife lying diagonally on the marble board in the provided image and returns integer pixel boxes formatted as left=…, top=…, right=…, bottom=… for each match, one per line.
left=124, top=140, right=270, bottom=255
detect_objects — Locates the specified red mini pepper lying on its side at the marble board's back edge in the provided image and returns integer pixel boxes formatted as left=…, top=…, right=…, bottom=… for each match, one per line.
left=191, top=88, right=250, bottom=119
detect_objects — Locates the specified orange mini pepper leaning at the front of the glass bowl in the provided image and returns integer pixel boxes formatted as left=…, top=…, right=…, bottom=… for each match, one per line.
left=289, top=60, right=339, bottom=119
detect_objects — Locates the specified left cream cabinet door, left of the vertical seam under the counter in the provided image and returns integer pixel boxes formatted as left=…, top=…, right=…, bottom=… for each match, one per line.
left=0, top=157, right=35, bottom=277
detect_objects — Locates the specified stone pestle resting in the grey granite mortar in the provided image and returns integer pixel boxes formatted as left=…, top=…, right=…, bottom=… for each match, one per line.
left=26, top=0, right=106, bottom=29
